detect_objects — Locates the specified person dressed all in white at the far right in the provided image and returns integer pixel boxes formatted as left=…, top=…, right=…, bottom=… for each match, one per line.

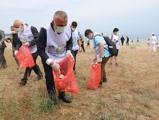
left=149, top=33, right=157, bottom=52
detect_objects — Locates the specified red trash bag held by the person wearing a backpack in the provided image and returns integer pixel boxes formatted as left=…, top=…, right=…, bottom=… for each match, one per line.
left=87, top=64, right=101, bottom=90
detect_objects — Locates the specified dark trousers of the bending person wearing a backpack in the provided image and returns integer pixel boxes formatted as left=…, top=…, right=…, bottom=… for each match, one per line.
left=100, top=57, right=109, bottom=84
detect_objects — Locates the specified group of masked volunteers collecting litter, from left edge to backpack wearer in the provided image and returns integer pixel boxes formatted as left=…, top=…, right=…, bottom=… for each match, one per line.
left=0, top=11, right=120, bottom=103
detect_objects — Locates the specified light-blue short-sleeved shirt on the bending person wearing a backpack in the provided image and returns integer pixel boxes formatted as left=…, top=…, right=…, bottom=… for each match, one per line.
left=94, top=33, right=110, bottom=57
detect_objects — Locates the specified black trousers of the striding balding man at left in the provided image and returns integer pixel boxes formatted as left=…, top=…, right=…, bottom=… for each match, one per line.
left=23, top=52, right=42, bottom=80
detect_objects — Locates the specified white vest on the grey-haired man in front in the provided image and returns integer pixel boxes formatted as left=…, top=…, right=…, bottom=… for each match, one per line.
left=43, top=24, right=71, bottom=62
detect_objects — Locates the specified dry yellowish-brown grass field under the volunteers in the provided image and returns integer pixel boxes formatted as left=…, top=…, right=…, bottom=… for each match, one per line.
left=0, top=44, right=159, bottom=120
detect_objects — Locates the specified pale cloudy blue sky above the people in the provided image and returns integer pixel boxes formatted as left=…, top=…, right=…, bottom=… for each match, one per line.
left=0, top=0, right=159, bottom=36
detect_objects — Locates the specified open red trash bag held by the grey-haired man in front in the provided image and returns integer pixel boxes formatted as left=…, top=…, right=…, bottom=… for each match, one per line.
left=53, top=56, right=79, bottom=94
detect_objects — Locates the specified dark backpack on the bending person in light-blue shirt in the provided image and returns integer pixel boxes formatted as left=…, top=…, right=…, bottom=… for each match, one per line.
left=95, top=34, right=118, bottom=56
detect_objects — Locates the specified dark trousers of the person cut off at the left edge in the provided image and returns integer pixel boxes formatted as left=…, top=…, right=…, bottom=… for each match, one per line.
left=0, top=47, right=7, bottom=68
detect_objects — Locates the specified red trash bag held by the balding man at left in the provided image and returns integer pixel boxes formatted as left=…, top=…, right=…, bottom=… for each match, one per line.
left=16, top=45, right=35, bottom=68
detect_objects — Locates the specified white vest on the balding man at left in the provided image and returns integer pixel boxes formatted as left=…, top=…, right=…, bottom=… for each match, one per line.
left=18, top=26, right=37, bottom=53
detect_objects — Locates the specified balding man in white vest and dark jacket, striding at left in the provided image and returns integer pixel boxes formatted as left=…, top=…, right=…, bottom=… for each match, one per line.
left=12, top=20, right=42, bottom=86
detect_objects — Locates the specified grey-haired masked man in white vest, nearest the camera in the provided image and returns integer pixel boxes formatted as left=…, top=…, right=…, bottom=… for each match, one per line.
left=38, top=11, right=73, bottom=103
